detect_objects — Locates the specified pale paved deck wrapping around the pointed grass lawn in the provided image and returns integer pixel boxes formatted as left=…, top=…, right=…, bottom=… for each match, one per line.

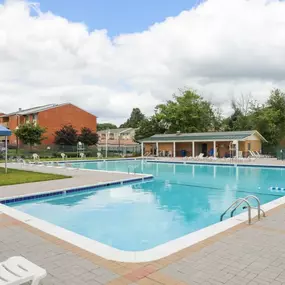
left=0, top=163, right=145, bottom=199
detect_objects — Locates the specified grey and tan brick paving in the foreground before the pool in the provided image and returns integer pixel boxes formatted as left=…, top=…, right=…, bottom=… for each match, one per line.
left=0, top=203, right=285, bottom=285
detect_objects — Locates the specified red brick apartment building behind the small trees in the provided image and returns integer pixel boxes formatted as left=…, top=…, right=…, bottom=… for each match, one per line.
left=0, top=103, right=97, bottom=145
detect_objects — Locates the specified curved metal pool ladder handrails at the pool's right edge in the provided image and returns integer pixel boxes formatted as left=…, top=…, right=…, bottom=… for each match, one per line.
left=220, top=195, right=265, bottom=224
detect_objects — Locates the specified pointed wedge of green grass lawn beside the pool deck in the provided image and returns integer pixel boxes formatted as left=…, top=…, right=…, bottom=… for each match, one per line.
left=0, top=167, right=70, bottom=186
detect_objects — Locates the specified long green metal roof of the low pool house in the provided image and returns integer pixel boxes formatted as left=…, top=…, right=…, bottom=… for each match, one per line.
left=141, top=131, right=266, bottom=142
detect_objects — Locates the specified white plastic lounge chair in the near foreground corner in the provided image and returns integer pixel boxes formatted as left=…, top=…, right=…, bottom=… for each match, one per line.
left=0, top=256, right=47, bottom=285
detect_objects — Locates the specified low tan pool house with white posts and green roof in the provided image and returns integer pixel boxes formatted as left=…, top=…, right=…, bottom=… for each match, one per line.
left=141, top=131, right=267, bottom=158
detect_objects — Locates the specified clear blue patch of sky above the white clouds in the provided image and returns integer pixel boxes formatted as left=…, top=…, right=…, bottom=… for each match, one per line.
left=21, top=0, right=198, bottom=37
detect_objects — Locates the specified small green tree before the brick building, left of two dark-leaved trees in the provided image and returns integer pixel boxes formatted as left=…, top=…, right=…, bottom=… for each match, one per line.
left=14, top=123, right=46, bottom=146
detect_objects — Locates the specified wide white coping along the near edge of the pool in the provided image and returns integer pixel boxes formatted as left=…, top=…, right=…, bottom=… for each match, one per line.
left=0, top=159, right=285, bottom=263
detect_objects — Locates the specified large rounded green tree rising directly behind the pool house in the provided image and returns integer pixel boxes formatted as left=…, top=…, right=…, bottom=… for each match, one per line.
left=155, top=90, right=221, bottom=133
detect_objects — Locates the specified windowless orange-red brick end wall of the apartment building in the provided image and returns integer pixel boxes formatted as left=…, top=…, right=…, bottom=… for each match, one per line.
left=38, top=104, right=97, bottom=145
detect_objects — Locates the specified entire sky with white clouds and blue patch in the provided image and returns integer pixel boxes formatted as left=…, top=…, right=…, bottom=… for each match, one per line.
left=0, top=0, right=285, bottom=123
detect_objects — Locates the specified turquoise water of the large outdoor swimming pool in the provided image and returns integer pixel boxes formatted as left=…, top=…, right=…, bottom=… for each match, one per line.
left=11, top=160, right=285, bottom=251
